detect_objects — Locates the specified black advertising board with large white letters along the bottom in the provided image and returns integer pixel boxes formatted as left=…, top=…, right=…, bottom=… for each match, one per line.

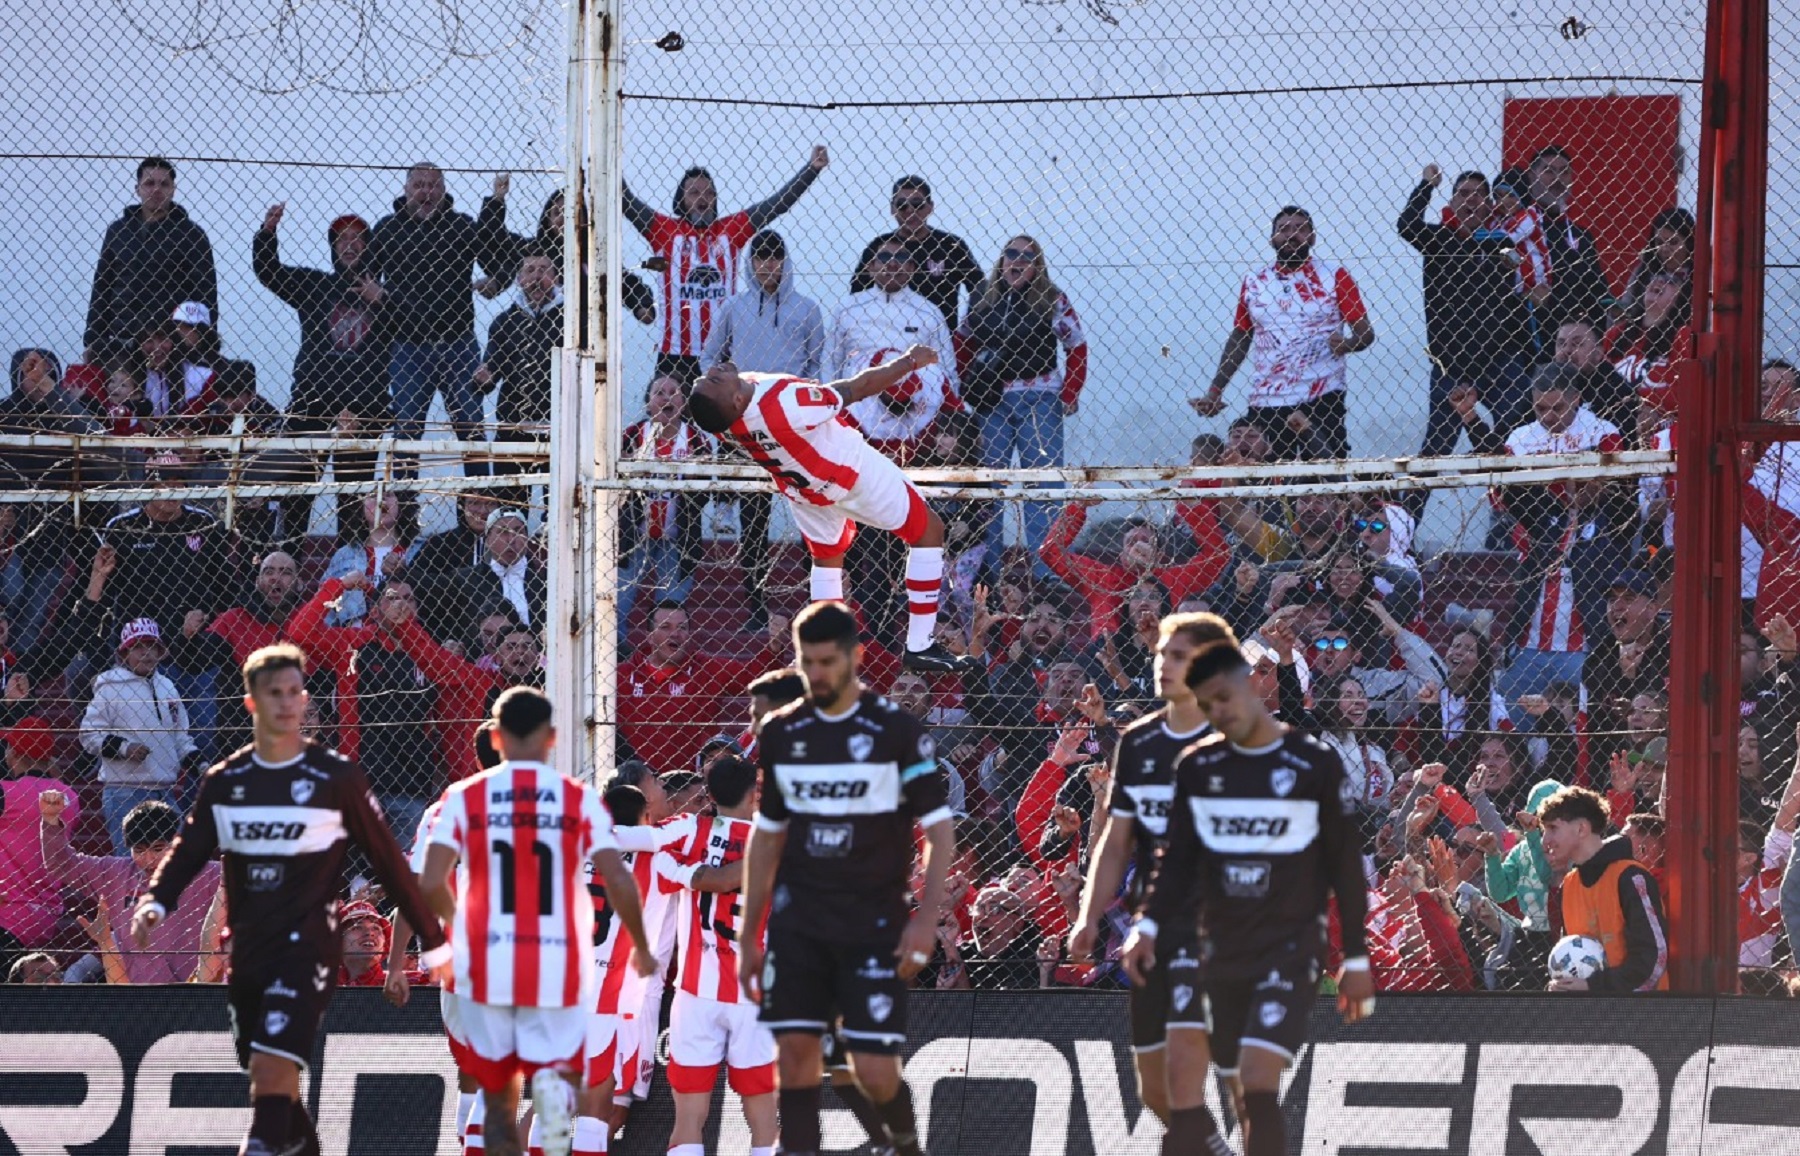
left=0, top=987, right=1800, bottom=1156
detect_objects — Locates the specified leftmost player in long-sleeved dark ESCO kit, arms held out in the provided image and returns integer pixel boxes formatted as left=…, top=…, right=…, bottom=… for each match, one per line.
left=131, top=643, right=450, bottom=1156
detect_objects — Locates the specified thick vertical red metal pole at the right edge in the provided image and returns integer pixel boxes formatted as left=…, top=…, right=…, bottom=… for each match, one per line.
left=1667, top=0, right=1769, bottom=994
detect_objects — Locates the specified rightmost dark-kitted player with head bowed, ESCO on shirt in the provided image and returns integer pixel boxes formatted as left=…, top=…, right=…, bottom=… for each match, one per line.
left=1123, top=614, right=1375, bottom=1156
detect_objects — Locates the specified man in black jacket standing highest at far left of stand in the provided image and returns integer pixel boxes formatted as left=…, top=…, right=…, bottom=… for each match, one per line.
left=81, top=157, right=220, bottom=364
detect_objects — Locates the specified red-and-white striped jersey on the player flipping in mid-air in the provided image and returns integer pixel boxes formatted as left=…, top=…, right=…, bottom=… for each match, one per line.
left=725, top=373, right=869, bottom=506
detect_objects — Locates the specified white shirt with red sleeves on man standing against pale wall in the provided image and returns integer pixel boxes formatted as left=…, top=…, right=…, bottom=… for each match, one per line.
left=1233, top=257, right=1368, bottom=407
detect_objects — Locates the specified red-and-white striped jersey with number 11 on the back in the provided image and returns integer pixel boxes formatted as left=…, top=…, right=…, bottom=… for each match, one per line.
left=432, top=762, right=617, bottom=1008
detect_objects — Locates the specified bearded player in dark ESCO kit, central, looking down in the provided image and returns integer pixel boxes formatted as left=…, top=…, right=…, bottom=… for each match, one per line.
left=738, top=601, right=956, bottom=1156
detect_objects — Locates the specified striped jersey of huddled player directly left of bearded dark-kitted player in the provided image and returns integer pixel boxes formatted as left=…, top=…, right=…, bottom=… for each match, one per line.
left=657, top=816, right=765, bottom=1003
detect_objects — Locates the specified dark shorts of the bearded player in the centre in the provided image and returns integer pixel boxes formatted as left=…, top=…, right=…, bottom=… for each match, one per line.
left=761, top=924, right=907, bottom=1055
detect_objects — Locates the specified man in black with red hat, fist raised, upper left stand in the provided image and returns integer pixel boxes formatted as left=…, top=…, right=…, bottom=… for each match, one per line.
left=250, top=203, right=392, bottom=540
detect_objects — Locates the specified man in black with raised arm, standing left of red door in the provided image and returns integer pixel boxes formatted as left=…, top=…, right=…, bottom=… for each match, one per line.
left=1399, top=164, right=1528, bottom=468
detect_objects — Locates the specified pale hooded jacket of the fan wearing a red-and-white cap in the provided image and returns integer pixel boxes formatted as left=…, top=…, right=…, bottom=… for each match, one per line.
left=81, top=664, right=196, bottom=787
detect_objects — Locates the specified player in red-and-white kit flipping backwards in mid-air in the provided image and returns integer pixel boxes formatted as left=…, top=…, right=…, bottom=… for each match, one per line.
left=688, top=346, right=979, bottom=673
